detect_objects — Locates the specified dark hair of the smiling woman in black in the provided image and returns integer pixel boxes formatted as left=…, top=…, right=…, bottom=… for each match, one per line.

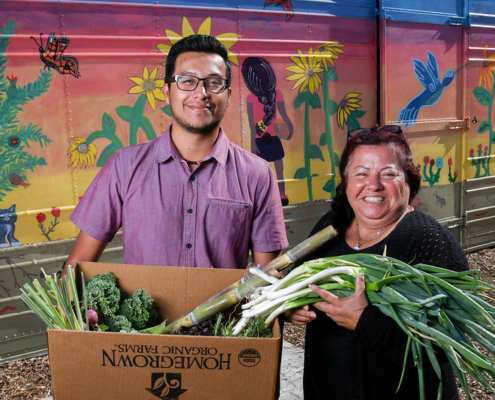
left=332, top=130, right=421, bottom=234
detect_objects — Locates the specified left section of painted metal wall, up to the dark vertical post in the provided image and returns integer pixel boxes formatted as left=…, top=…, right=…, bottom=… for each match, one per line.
left=0, top=1, right=376, bottom=362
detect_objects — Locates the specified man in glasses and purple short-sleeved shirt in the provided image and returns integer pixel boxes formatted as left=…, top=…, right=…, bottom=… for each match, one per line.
left=67, top=35, right=288, bottom=268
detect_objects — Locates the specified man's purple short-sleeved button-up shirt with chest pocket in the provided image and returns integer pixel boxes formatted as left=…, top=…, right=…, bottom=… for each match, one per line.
left=70, top=129, right=288, bottom=268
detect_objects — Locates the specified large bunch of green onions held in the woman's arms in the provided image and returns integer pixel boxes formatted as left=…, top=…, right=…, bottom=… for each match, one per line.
left=234, top=254, right=495, bottom=399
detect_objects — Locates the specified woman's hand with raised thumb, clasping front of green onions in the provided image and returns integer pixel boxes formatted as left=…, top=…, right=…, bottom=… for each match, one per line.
left=309, top=274, right=369, bottom=331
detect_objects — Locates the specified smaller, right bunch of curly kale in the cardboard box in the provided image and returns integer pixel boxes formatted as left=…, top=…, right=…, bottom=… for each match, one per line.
left=119, top=289, right=158, bottom=330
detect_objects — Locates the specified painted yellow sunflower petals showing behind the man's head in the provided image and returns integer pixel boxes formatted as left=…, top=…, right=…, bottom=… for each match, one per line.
left=156, top=17, right=241, bottom=65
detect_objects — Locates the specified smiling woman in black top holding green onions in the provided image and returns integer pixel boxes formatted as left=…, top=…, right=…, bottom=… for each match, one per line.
left=284, top=126, right=469, bottom=400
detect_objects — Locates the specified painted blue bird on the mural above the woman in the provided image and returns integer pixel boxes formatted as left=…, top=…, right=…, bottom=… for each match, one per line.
left=398, top=52, right=455, bottom=129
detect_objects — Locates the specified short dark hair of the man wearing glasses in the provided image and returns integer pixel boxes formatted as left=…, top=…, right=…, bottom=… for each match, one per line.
left=165, top=35, right=232, bottom=87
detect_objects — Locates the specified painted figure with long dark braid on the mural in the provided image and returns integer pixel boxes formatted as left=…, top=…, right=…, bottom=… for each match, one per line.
left=242, top=57, right=294, bottom=205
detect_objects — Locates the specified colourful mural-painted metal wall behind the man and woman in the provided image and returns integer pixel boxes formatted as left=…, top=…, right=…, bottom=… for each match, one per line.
left=0, top=0, right=495, bottom=362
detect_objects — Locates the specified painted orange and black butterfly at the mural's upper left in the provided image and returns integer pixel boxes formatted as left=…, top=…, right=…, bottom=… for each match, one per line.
left=31, top=32, right=81, bottom=78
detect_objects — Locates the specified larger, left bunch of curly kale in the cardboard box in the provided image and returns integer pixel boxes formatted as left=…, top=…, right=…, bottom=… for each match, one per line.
left=86, top=272, right=127, bottom=323
